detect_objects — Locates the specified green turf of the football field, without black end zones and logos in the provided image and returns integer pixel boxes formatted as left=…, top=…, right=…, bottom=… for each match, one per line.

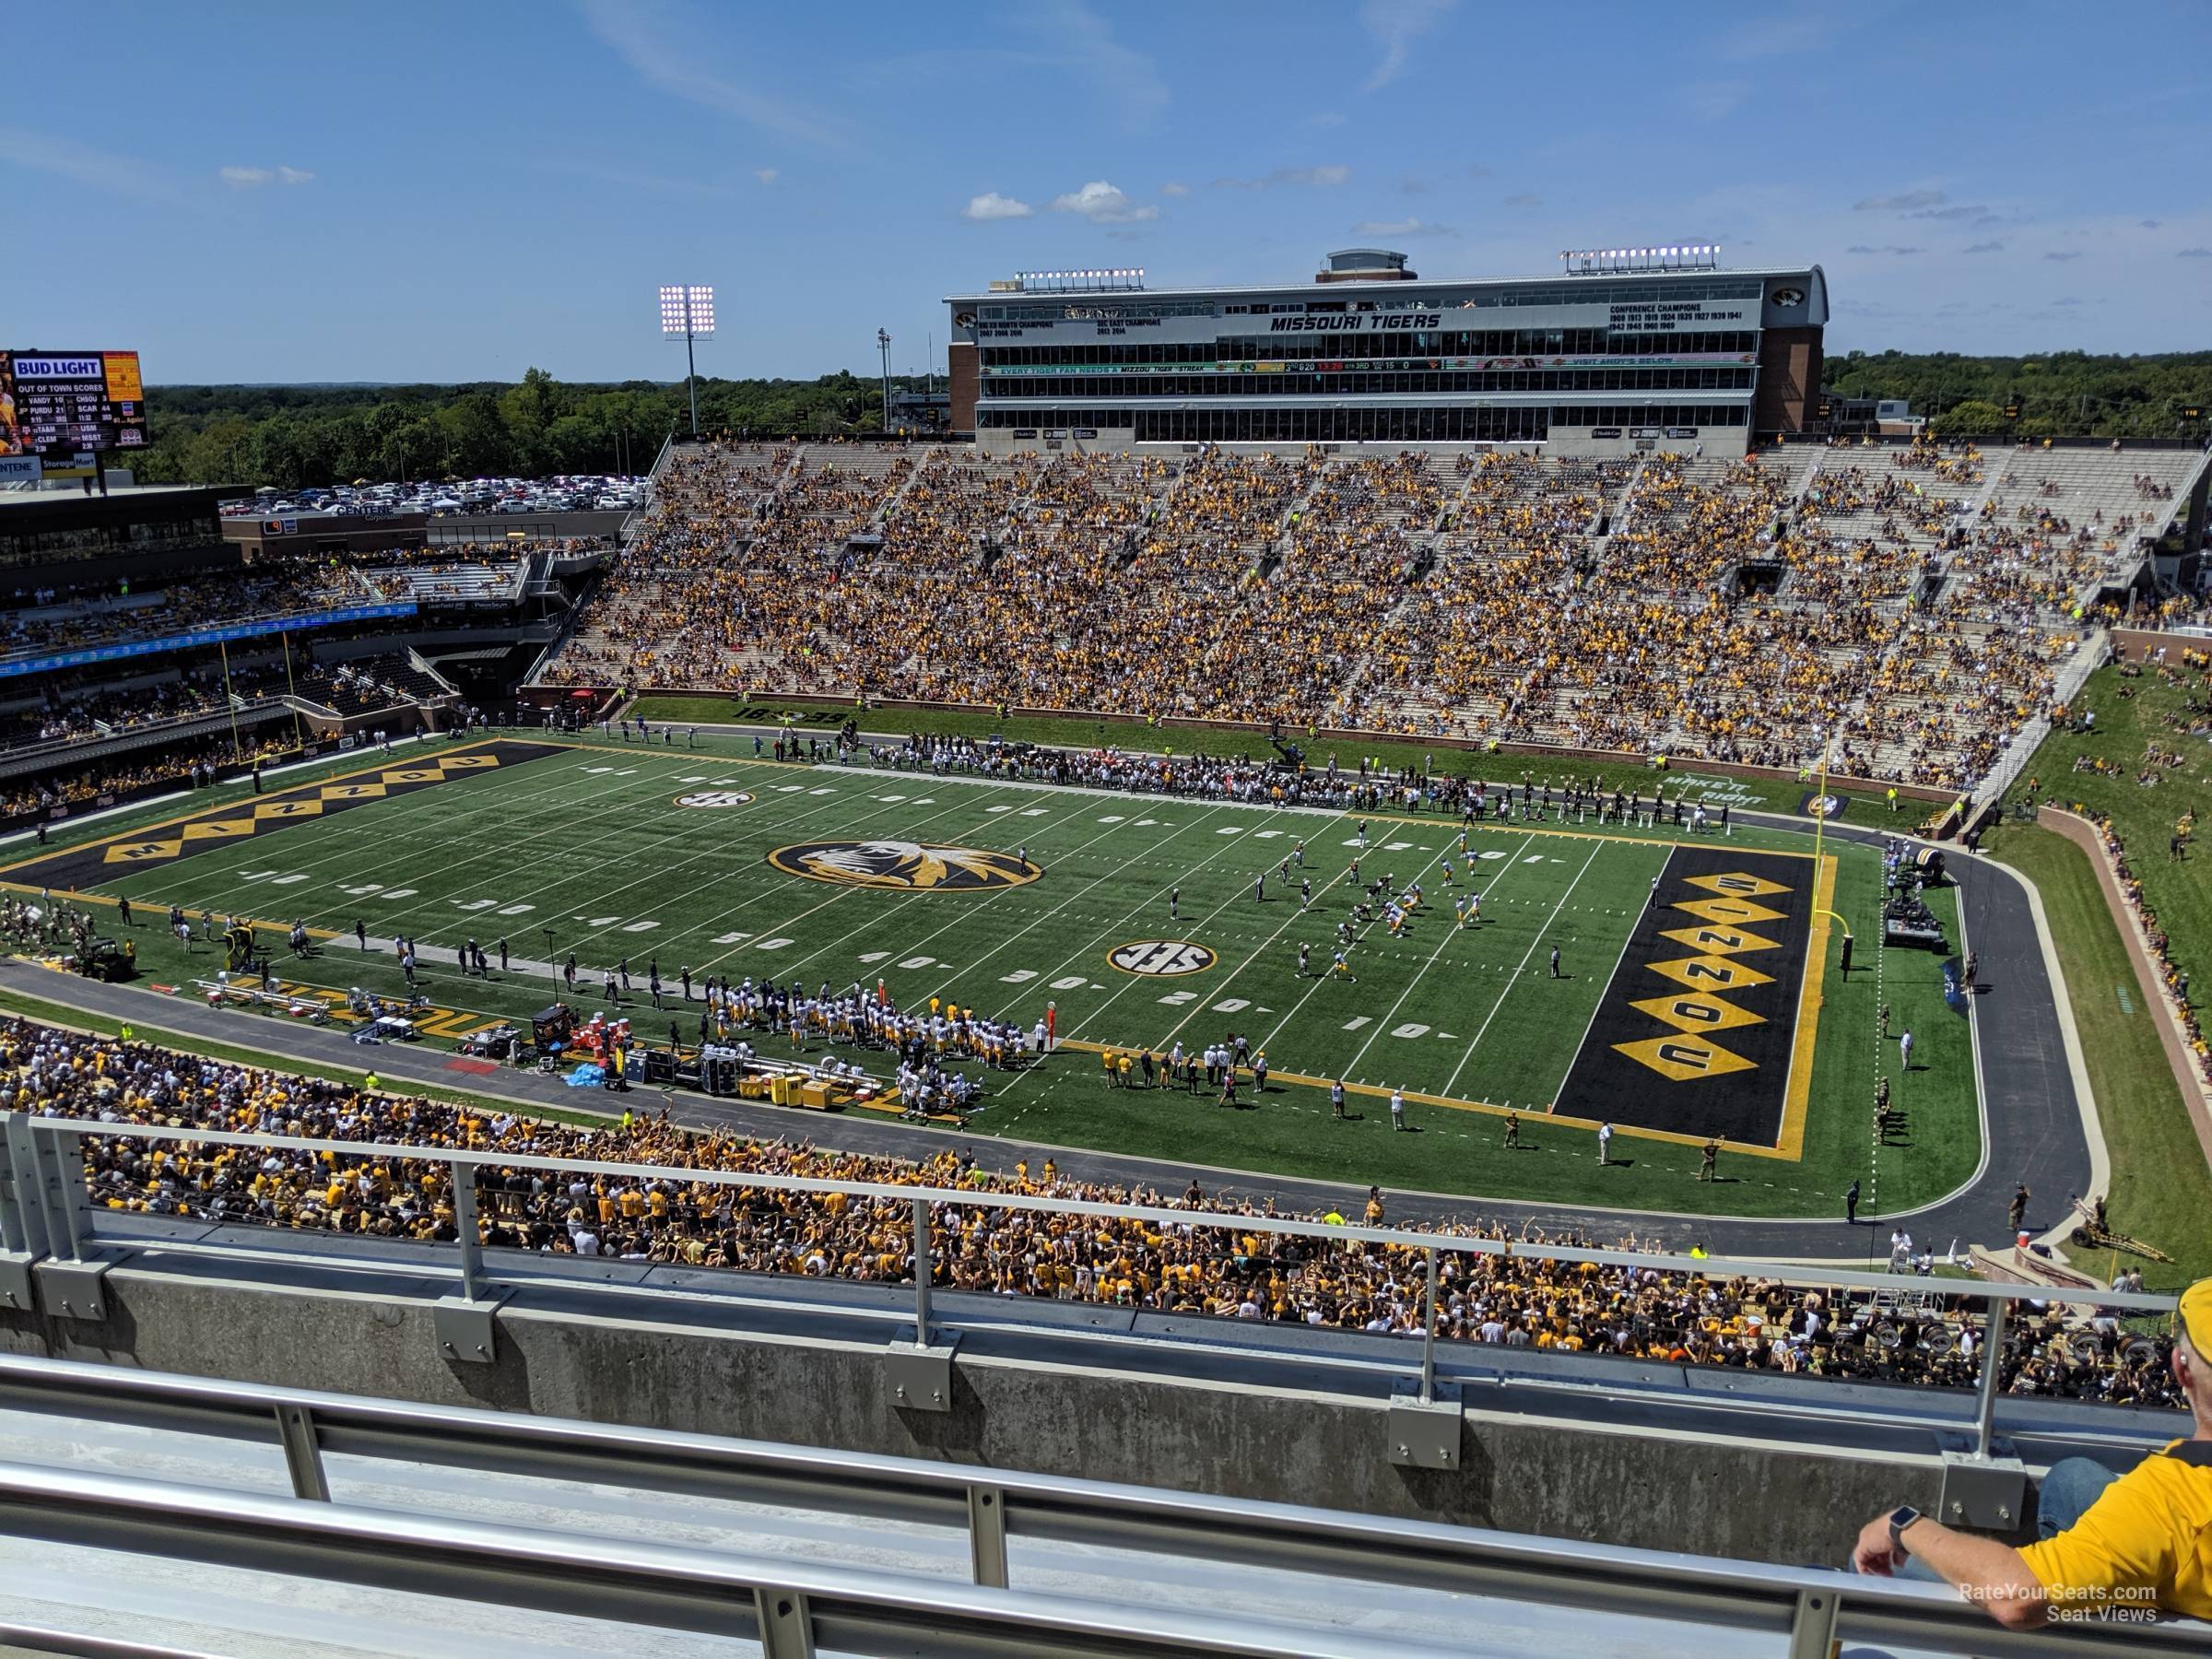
left=17, top=739, right=1978, bottom=1215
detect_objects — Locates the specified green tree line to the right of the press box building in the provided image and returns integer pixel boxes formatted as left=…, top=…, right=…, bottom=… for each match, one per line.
left=1823, top=352, right=2212, bottom=438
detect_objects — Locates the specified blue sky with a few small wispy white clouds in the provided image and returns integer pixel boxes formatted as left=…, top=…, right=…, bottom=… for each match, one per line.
left=0, top=0, right=2212, bottom=382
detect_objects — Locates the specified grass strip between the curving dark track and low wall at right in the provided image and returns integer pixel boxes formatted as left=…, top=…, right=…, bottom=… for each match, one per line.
left=1982, top=825, right=2212, bottom=1289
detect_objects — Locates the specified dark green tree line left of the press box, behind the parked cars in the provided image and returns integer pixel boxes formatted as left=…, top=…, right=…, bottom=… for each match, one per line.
left=128, top=367, right=942, bottom=488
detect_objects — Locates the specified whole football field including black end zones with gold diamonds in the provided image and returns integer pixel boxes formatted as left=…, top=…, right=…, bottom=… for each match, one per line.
left=6, top=739, right=1973, bottom=1212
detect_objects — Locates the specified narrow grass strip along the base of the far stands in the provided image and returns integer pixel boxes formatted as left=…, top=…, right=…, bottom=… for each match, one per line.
left=629, top=692, right=1902, bottom=817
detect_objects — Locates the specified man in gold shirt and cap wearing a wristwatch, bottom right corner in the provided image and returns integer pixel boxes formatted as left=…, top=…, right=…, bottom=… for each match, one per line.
left=1852, top=1278, right=2212, bottom=1630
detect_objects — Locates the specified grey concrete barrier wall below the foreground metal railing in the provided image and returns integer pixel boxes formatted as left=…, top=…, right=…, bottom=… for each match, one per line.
left=0, top=1265, right=1942, bottom=1564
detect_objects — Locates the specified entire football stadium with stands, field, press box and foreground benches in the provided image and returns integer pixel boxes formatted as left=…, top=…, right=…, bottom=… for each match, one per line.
left=0, top=97, right=2212, bottom=1654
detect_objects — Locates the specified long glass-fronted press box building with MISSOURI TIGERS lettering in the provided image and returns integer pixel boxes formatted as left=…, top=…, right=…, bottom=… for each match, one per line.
left=945, top=245, right=1827, bottom=455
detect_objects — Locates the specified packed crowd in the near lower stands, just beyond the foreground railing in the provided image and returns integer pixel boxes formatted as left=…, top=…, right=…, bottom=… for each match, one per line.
left=0, top=1019, right=2177, bottom=1406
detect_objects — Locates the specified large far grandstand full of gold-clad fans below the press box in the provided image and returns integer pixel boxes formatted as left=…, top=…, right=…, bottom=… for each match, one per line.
left=551, top=442, right=2194, bottom=787
